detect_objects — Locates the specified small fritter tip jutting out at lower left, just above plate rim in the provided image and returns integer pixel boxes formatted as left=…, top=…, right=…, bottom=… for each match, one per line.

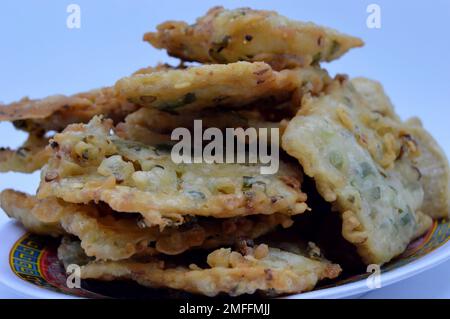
left=0, top=189, right=64, bottom=236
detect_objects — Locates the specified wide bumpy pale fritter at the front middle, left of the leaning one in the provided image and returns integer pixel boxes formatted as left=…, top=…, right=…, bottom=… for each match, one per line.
left=38, top=117, right=307, bottom=227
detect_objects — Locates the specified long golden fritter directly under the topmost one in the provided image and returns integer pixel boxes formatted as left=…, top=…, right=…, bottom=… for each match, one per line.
left=115, top=62, right=328, bottom=112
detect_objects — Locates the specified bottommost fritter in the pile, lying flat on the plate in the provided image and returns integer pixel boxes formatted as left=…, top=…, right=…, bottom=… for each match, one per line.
left=58, top=243, right=341, bottom=296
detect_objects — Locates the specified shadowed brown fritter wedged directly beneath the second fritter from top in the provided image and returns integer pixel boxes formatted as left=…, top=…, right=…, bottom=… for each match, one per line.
left=114, top=68, right=331, bottom=145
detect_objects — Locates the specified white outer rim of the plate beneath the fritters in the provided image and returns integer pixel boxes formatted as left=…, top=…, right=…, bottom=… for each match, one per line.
left=0, top=221, right=450, bottom=299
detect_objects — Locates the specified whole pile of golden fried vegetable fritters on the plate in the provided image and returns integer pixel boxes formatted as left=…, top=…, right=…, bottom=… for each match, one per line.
left=0, top=7, right=450, bottom=296
